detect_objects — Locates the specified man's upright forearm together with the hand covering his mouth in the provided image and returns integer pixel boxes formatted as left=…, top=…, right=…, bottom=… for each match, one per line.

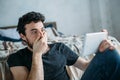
left=27, top=32, right=48, bottom=80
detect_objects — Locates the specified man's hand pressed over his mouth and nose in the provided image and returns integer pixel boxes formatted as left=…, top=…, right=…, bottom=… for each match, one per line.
left=33, top=32, right=48, bottom=54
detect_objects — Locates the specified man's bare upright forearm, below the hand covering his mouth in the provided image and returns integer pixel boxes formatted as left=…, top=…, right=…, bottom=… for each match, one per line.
left=27, top=54, right=44, bottom=80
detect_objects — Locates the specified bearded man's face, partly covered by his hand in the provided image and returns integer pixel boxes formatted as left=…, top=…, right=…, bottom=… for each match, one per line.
left=21, top=21, right=45, bottom=48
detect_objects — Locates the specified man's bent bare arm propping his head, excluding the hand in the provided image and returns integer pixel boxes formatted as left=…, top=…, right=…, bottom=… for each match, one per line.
left=10, top=55, right=44, bottom=80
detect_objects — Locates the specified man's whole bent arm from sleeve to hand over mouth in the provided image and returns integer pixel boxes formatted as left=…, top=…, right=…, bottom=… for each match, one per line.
left=11, top=31, right=48, bottom=80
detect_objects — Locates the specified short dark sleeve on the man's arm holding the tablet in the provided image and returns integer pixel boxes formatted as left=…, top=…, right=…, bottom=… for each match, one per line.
left=61, top=43, right=79, bottom=66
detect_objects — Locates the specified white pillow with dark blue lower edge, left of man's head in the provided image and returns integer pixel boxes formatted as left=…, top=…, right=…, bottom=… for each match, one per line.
left=0, top=28, right=21, bottom=41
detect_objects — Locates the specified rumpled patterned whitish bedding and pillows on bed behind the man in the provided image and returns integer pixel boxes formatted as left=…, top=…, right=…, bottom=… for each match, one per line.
left=0, top=22, right=120, bottom=80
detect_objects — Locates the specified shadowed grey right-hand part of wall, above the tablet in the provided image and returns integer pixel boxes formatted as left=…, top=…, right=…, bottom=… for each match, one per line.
left=90, top=0, right=120, bottom=41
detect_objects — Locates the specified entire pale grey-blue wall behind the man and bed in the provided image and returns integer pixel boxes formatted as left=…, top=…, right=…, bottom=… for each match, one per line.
left=0, top=0, right=120, bottom=40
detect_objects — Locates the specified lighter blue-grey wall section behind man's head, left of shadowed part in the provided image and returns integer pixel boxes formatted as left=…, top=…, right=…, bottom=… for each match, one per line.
left=0, top=0, right=94, bottom=35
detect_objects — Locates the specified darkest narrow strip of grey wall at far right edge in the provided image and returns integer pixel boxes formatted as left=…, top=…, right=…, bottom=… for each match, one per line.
left=109, top=0, right=120, bottom=41
